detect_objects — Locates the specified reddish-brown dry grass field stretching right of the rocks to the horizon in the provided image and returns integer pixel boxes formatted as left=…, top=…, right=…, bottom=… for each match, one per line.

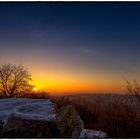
left=53, top=94, right=140, bottom=138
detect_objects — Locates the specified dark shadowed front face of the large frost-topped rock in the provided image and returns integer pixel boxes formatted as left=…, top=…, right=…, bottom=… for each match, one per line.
left=2, top=118, right=60, bottom=138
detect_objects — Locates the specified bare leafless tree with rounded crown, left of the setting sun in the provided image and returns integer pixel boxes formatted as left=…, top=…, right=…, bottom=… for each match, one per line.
left=0, top=64, right=32, bottom=97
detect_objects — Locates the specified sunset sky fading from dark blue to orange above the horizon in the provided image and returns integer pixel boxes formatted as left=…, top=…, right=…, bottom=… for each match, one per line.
left=0, top=2, right=140, bottom=93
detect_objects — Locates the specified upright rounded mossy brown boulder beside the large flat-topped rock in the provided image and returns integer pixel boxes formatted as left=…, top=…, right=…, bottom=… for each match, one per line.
left=58, top=106, right=84, bottom=138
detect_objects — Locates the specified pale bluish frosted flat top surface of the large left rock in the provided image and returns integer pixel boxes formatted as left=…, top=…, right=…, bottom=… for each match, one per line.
left=0, top=98, right=55, bottom=123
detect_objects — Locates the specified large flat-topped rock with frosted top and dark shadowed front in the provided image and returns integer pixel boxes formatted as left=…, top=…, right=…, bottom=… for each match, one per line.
left=3, top=100, right=60, bottom=138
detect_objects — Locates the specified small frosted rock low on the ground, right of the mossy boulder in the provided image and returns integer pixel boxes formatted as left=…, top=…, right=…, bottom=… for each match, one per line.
left=79, top=129, right=107, bottom=139
